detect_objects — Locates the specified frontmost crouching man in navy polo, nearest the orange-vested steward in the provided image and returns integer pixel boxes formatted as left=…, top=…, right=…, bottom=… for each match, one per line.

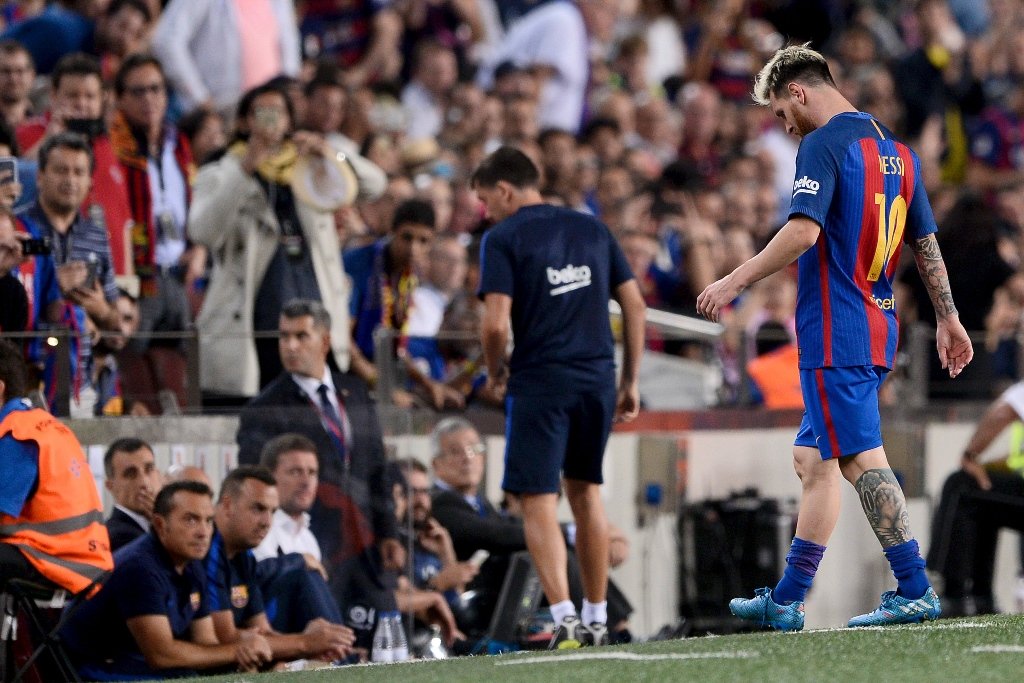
left=61, top=481, right=271, bottom=681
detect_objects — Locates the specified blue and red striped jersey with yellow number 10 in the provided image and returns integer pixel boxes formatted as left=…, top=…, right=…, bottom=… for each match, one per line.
left=790, top=112, right=936, bottom=369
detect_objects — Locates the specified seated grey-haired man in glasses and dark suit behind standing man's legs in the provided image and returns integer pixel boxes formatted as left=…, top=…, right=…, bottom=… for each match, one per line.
left=430, top=418, right=633, bottom=642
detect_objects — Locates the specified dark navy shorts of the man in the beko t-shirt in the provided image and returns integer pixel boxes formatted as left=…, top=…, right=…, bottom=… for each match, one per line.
left=502, top=385, right=615, bottom=494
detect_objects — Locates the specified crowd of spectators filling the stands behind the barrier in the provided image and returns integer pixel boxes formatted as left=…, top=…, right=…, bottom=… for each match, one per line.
left=6, top=0, right=1024, bottom=416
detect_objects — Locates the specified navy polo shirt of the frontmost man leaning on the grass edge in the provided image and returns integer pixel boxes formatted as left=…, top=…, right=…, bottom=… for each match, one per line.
left=61, top=533, right=210, bottom=680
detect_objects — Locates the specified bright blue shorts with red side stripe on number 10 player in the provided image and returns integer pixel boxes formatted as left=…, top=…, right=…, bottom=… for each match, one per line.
left=794, top=366, right=889, bottom=460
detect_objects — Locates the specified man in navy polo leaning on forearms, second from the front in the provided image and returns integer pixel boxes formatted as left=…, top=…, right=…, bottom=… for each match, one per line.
left=203, top=465, right=355, bottom=661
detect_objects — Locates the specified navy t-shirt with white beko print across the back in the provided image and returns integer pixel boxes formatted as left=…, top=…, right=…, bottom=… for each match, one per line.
left=479, top=204, right=633, bottom=395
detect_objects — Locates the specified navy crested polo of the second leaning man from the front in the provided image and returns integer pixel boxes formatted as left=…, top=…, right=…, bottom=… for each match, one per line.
left=203, top=531, right=264, bottom=629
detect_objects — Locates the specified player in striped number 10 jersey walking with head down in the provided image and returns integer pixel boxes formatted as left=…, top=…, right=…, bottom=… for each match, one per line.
left=697, top=45, right=974, bottom=631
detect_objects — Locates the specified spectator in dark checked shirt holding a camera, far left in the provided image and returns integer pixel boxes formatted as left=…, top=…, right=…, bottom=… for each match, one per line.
left=18, top=133, right=120, bottom=417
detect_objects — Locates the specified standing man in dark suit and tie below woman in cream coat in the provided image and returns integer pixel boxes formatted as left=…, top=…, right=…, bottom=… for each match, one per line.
left=238, top=299, right=406, bottom=643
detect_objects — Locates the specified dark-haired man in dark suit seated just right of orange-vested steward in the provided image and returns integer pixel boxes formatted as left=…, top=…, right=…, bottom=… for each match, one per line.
left=103, top=437, right=163, bottom=551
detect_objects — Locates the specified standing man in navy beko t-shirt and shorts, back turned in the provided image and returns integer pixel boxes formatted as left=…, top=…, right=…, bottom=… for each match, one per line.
left=473, top=147, right=644, bottom=648
